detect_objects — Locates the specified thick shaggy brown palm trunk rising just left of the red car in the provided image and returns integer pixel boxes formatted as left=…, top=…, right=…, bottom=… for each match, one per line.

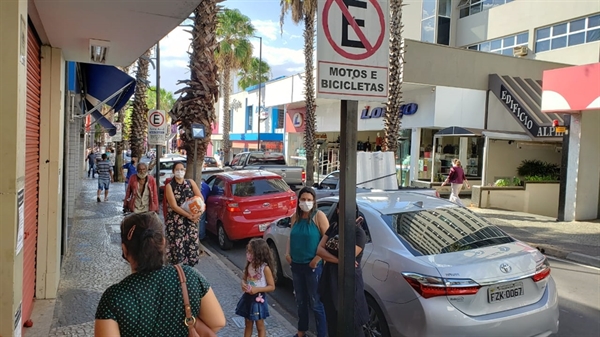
left=171, top=0, right=221, bottom=178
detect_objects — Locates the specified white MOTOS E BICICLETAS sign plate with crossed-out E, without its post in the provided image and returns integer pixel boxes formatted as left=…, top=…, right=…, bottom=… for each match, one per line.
left=317, top=0, right=389, bottom=101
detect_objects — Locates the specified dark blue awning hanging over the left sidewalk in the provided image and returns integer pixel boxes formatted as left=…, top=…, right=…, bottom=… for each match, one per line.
left=80, top=63, right=135, bottom=136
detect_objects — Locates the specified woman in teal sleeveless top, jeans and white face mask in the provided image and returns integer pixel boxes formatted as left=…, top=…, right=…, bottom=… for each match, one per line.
left=285, top=187, right=331, bottom=337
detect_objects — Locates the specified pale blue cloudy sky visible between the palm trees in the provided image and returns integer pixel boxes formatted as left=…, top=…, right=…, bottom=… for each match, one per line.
left=149, top=0, right=304, bottom=97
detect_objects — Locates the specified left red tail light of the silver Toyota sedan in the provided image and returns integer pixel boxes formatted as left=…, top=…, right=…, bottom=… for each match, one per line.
left=402, top=273, right=481, bottom=298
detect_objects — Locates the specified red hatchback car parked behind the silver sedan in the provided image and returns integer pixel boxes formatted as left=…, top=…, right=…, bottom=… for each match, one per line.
left=206, top=170, right=296, bottom=250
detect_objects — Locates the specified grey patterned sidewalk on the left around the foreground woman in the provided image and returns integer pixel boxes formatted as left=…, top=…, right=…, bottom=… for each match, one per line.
left=24, top=179, right=296, bottom=337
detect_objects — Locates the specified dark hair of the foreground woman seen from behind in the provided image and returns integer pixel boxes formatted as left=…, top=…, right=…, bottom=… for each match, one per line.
left=121, top=212, right=166, bottom=273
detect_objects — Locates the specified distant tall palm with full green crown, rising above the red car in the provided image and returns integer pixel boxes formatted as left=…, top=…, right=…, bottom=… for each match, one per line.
left=215, top=9, right=254, bottom=161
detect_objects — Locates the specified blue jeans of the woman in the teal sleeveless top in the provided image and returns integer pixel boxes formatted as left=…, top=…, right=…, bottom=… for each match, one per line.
left=291, top=262, right=327, bottom=337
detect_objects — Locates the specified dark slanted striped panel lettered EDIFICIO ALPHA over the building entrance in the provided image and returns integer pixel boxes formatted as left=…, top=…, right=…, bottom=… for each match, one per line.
left=488, top=74, right=563, bottom=138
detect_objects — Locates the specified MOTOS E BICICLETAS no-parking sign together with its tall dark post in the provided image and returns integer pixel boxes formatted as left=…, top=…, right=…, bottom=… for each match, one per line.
left=317, top=0, right=389, bottom=336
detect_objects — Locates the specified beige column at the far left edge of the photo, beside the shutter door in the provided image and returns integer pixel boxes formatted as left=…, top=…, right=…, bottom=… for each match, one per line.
left=0, top=1, right=27, bottom=336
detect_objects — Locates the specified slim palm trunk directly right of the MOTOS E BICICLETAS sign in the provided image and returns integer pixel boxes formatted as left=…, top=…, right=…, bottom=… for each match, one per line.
left=383, top=0, right=404, bottom=153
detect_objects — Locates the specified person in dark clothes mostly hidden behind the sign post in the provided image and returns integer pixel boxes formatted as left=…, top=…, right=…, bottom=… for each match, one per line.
left=317, top=204, right=369, bottom=337
